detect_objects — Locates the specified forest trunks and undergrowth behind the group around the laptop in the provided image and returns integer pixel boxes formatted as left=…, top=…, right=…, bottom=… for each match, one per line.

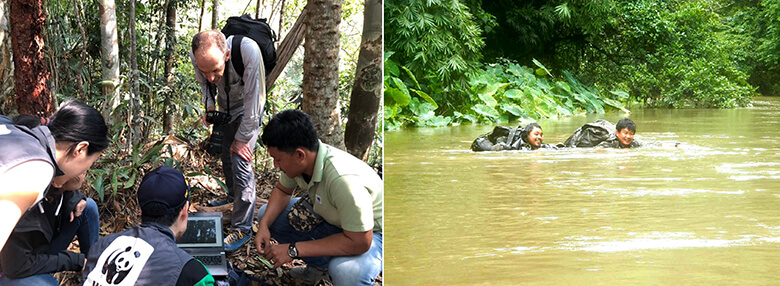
left=0, top=0, right=383, bottom=285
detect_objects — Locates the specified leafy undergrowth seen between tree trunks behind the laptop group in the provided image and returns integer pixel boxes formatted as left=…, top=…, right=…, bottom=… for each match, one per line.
left=0, top=0, right=382, bottom=201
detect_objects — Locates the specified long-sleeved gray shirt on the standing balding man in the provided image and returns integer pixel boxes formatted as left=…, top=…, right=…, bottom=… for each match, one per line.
left=190, top=36, right=265, bottom=142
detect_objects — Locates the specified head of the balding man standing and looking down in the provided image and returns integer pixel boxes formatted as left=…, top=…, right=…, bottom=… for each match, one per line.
left=192, top=30, right=230, bottom=83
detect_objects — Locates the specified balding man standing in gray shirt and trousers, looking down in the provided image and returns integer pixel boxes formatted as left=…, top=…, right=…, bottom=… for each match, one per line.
left=190, top=30, right=265, bottom=253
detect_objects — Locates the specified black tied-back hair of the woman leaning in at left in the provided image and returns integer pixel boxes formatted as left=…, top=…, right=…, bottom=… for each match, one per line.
left=49, top=100, right=108, bottom=155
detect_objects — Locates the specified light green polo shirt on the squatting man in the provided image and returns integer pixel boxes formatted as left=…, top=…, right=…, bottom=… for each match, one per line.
left=279, top=142, right=384, bottom=233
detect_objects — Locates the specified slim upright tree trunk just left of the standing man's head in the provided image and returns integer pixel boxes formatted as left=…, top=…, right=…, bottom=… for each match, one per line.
left=163, top=0, right=178, bottom=134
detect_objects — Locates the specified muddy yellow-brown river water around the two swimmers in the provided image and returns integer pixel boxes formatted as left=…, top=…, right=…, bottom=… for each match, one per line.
left=385, top=98, right=780, bottom=285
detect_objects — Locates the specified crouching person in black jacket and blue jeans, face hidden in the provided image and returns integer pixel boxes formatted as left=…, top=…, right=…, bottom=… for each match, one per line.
left=0, top=172, right=100, bottom=285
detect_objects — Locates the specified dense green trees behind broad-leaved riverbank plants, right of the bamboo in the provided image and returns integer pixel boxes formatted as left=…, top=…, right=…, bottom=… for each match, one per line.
left=468, top=0, right=760, bottom=108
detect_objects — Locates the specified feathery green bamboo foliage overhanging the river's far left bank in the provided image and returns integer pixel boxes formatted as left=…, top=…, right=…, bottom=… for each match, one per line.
left=384, top=0, right=484, bottom=111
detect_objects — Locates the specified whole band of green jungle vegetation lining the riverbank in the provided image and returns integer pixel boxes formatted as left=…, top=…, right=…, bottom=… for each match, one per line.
left=384, top=0, right=780, bottom=129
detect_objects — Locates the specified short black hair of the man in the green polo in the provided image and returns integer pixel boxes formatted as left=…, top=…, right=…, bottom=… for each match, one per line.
left=261, top=109, right=320, bottom=154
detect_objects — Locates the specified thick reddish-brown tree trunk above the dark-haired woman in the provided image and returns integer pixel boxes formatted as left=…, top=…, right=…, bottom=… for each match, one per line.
left=9, top=0, right=54, bottom=116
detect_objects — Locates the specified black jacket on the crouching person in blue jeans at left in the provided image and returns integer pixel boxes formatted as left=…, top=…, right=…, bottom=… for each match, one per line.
left=0, top=191, right=86, bottom=279
